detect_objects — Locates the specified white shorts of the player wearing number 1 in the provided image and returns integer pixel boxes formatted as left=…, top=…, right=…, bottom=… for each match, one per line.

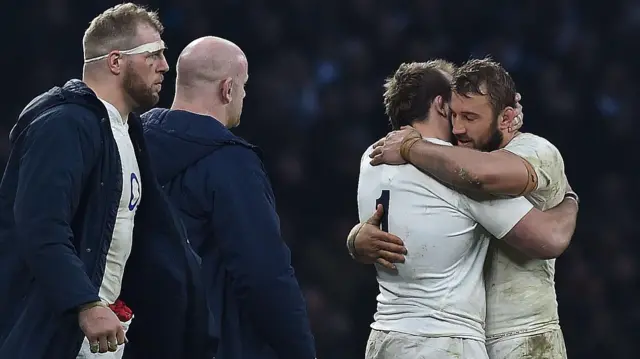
left=365, top=329, right=489, bottom=359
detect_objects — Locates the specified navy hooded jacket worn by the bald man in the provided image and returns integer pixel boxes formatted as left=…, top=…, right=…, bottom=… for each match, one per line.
left=142, top=109, right=315, bottom=359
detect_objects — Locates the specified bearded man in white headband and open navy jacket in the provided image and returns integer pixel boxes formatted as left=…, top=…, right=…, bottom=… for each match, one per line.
left=0, top=3, right=213, bottom=359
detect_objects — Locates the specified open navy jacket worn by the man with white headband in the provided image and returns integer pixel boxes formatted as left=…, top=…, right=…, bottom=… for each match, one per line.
left=0, top=80, right=214, bottom=359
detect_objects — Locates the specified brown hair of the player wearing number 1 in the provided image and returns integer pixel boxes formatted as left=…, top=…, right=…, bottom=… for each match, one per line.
left=383, top=60, right=455, bottom=130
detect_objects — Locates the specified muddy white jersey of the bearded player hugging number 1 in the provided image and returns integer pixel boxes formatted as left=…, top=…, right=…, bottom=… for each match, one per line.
left=485, top=133, right=567, bottom=340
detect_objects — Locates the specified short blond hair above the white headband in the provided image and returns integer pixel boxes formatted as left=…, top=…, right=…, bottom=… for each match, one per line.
left=82, top=3, right=164, bottom=60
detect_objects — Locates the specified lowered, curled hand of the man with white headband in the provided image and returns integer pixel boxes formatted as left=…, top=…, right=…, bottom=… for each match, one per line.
left=78, top=305, right=125, bottom=353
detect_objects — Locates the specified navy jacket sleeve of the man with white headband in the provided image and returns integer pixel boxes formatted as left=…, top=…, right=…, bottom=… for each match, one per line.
left=13, top=111, right=100, bottom=312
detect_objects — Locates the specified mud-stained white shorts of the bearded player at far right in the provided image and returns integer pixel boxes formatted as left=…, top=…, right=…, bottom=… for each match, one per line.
left=487, top=329, right=567, bottom=359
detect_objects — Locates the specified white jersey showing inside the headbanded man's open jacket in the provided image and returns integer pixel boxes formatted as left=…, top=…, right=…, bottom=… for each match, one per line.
left=98, top=99, right=142, bottom=304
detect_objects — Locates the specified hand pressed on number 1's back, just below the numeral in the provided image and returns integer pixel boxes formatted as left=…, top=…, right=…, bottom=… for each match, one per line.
left=354, top=205, right=407, bottom=270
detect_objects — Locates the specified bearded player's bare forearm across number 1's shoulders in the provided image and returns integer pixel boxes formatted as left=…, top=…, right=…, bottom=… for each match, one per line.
left=404, top=140, right=538, bottom=196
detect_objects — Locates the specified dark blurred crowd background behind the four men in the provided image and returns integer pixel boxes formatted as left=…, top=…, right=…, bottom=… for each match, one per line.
left=6, top=0, right=640, bottom=359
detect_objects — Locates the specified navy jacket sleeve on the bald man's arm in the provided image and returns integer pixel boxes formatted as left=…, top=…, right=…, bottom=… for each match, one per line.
left=211, top=145, right=315, bottom=359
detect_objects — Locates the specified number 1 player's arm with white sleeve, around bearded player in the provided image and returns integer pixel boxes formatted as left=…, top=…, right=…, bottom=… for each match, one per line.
left=465, top=191, right=578, bottom=259
